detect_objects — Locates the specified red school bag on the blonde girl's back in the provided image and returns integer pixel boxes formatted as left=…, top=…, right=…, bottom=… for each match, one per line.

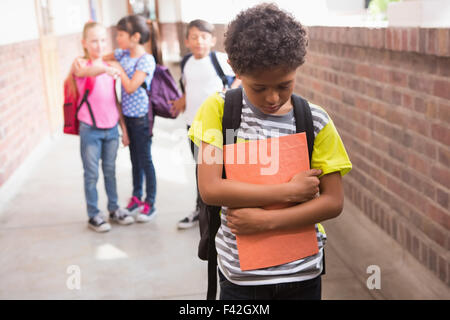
left=63, top=77, right=97, bottom=135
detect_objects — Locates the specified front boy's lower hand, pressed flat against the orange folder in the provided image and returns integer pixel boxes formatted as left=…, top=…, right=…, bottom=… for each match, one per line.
left=227, top=208, right=268, bottom=235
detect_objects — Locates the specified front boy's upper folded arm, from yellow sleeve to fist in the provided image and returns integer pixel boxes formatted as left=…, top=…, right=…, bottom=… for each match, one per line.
left=198, top=142, right=321, bottom=208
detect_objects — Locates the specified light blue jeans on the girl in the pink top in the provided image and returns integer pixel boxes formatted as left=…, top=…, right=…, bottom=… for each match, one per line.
left=80, top=122, right=119, bottom=218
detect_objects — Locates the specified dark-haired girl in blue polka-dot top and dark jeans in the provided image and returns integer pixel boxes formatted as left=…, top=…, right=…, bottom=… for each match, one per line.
left=104, top=15, right=156, bottom=222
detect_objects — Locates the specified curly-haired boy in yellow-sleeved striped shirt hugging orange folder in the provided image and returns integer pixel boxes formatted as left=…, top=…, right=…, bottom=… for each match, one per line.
left=189, top=4, right=352, bottom=300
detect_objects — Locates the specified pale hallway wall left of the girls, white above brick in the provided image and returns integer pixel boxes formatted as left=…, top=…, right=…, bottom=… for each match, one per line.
left=0, top=0, right=127, bottom=190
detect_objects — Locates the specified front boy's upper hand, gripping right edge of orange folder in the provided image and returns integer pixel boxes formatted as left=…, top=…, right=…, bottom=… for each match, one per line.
left=288, top=169, right=322, bottom=203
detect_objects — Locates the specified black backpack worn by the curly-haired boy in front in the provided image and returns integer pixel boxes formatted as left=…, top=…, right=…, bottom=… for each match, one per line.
left=198, top=88, right=318, bottom=300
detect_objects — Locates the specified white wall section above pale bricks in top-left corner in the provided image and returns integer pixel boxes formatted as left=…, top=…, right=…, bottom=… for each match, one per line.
left=0, top=0, right=39, bottom=45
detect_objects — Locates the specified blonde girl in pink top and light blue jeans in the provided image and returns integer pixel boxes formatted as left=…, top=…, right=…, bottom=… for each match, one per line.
left=69, top=22, right=134, bottom=232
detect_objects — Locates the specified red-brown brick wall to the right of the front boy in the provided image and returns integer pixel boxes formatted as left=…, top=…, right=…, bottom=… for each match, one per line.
left=296, top=27, right=450, bottom=284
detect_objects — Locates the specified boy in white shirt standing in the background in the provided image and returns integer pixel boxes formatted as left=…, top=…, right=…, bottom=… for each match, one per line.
left=172, top=20, right=240, bottom=229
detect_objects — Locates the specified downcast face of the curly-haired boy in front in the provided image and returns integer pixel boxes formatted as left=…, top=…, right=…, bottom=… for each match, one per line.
left=236, top=67, right=297, bottom=115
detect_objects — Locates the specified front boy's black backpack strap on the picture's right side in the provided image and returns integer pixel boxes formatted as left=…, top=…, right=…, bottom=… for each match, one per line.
left=292, top=94, right=315, bottom=164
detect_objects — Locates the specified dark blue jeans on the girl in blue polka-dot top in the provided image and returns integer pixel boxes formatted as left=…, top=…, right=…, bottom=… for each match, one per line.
left=124, top=115, right=156, bottom=207
